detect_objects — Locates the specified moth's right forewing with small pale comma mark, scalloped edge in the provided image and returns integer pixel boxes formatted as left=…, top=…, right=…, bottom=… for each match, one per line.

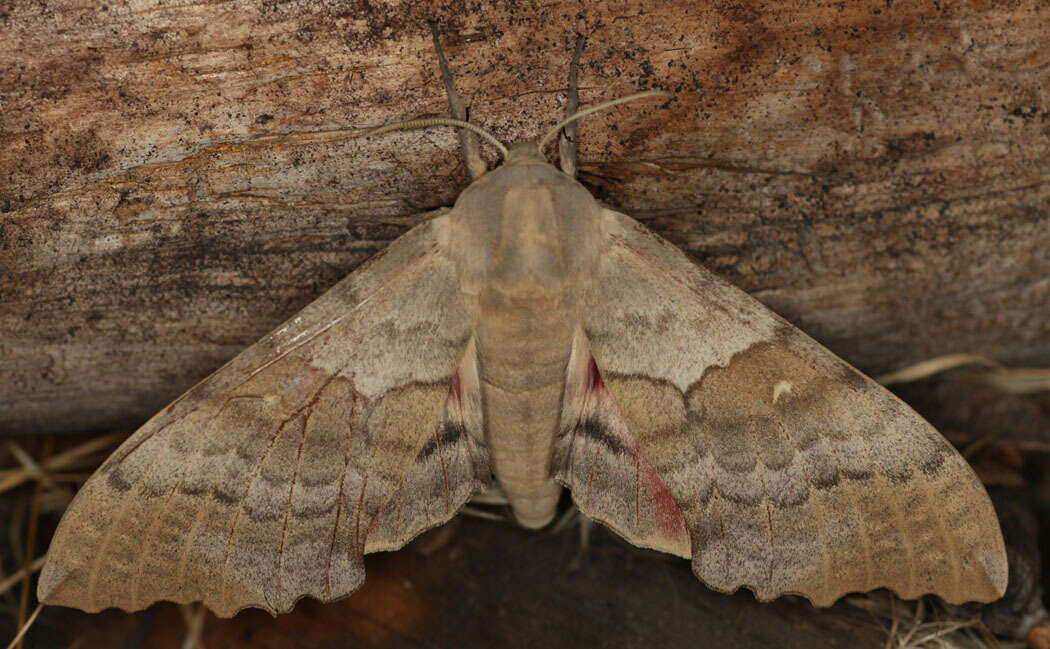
left=573, top=211, right=1007, bottom=605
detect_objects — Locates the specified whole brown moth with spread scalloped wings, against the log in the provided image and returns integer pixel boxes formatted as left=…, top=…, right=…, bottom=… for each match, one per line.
left=39, top=31, right=1007, bottom=616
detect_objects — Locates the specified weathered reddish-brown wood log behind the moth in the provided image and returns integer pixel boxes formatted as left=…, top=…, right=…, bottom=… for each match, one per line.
left=0, top=0, right=1050, bottom=434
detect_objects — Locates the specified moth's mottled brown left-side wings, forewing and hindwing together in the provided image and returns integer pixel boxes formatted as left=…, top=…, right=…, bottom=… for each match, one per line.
left=39, top=216, right=489, bottom=616
